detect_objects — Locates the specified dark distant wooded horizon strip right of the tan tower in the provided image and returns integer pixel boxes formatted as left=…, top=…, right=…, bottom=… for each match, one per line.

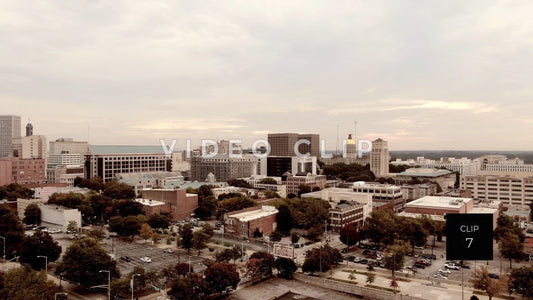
left=390, top=150, right=533, bottom=164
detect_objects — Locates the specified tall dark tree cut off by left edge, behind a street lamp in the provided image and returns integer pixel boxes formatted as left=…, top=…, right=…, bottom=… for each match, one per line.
left=0, top=204, right=24, bottom=259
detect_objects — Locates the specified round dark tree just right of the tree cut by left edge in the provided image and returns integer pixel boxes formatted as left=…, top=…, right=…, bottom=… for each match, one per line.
left=20, top=231, right=61, bottom=270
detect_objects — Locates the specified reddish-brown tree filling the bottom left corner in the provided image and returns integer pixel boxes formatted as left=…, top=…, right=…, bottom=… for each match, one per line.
left=0, top=266, right=61, bottom=300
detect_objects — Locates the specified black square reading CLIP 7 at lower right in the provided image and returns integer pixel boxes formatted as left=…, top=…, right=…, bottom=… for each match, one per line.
left=446, top=214, right=494, bottom=260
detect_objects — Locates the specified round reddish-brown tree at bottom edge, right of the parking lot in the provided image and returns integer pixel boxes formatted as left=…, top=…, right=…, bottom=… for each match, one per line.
left=204, top=263, right=241, bottom=294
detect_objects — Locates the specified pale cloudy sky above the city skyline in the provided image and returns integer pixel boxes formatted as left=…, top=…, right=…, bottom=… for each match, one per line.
left=0, top=0, right=533, bottom=150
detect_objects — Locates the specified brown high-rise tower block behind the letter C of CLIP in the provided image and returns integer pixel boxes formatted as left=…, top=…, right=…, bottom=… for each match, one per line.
left=268, top=133, right=320, bottom=157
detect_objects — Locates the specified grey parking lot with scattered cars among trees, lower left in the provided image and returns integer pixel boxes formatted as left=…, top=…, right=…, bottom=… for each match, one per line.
left=104, top=241, right=206, bottom=275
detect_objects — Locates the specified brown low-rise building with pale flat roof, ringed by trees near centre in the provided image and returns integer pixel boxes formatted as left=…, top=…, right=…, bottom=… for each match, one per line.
left=224, top=205, right=278, bottom=238
